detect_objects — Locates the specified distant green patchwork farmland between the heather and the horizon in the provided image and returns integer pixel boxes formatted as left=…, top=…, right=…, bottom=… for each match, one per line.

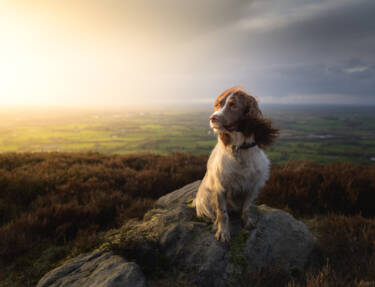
left=0, top=106, right=375, bottom=163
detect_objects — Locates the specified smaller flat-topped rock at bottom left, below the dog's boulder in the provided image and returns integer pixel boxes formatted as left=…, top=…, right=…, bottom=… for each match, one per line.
left=37, top=250, right=146, bottom=287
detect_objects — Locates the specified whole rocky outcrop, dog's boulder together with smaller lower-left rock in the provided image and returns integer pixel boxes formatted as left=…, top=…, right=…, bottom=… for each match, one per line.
left=38, top=181, right=314, bottom=287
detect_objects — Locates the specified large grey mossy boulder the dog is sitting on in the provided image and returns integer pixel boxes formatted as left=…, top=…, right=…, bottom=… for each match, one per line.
left=122, top=181, right=314, bottom=286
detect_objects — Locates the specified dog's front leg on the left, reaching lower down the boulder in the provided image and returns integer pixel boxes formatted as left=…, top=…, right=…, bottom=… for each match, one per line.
left=215, top=191, right=230, bottom=243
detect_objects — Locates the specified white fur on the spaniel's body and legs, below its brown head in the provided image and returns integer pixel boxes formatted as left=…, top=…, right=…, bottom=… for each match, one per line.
left=195, top=132, right=270, bottom=241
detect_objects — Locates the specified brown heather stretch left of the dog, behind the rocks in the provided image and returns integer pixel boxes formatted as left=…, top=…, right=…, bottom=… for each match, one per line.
left=0, top=153, right=206, bottom=265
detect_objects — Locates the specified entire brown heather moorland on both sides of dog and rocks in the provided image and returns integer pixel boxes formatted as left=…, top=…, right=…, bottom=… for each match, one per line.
left=0, top=153, right=375, bottom=286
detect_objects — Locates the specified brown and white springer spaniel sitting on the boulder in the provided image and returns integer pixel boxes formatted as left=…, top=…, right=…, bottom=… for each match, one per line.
left=195, top=87, right=278, bottom=242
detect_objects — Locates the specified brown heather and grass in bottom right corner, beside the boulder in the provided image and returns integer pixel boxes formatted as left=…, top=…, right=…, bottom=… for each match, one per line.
left=287, top=215, right=375, bottom=287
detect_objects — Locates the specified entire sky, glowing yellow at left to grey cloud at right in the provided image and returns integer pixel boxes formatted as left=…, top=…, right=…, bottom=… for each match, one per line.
left=0, top=0, right=375, bottom=107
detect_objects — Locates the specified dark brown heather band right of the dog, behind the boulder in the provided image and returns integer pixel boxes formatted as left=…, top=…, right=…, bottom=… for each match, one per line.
left=258, top=162, right=375, bottom=217
